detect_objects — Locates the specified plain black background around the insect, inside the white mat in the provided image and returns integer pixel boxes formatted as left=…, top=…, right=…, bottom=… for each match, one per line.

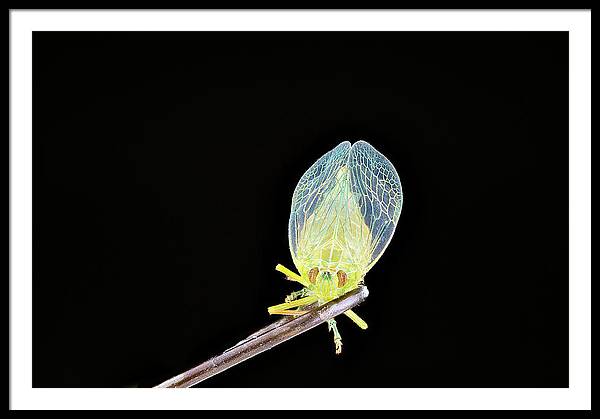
left=33, top=32, right=568, bottom=387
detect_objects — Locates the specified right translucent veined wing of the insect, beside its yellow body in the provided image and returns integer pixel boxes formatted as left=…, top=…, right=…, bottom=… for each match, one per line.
left=348, top=141, right=402, bottom=273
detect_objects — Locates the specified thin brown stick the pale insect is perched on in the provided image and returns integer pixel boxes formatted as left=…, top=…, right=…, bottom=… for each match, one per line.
left=156, top=286, right=369, bottom=388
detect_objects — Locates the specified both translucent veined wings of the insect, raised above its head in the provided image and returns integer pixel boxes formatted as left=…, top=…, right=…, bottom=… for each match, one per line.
left=289, top=141, right=402, bottom=280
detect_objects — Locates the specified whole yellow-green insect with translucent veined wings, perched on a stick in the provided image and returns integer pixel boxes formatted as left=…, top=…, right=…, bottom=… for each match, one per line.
left=268, top=141, right=403, bottom=354
